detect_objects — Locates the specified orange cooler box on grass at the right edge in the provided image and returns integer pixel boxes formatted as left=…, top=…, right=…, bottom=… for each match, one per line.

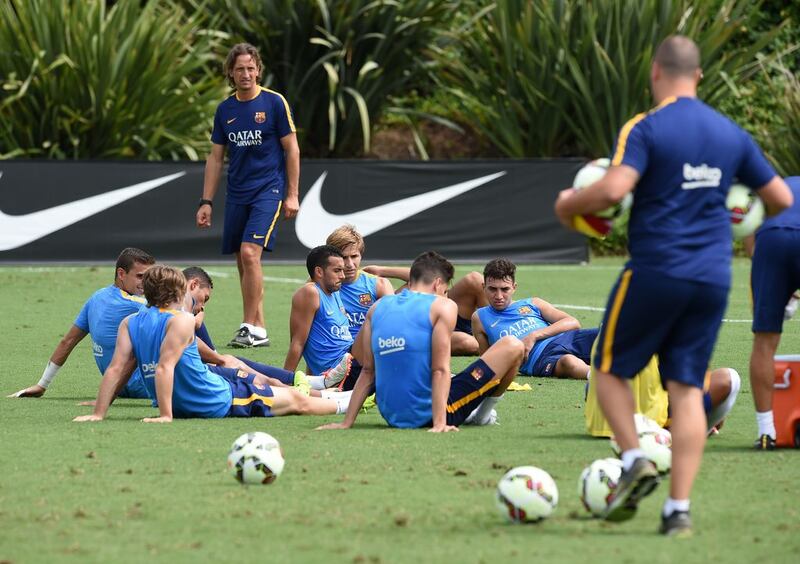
left=772, top=354, right=800, bottom=448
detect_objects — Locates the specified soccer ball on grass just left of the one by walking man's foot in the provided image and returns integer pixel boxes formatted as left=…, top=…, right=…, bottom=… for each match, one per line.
left=496, top=466, right=558, bottom=523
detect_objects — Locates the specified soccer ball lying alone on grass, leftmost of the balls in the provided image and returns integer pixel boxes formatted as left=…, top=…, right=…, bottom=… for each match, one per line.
left=228, top=432, right=284, bottom=484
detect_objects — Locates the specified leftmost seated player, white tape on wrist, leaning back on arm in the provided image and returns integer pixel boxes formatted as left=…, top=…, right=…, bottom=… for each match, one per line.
left=9, top=247, right=155, bottom=398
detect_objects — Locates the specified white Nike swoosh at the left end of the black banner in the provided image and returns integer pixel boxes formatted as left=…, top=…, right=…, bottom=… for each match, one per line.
left=0, top=172, right=186, bottom=251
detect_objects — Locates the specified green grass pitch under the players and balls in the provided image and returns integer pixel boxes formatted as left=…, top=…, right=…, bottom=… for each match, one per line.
left=0, top=260, right=800, bottom=563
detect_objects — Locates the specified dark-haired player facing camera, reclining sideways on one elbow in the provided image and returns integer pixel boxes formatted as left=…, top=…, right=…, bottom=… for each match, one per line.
left=472, top=259, right=598, bottom=380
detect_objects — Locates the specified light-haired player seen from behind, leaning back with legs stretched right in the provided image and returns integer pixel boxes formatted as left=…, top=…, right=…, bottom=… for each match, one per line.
left=74, top=265, right=350, bottom=423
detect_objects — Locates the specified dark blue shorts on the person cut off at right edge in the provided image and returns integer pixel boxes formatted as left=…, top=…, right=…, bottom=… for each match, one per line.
left=750, top=229, right=800, bottom=333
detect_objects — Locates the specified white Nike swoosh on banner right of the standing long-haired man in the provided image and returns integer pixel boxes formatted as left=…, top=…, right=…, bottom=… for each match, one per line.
left=295, top=171, right=506, bottom=249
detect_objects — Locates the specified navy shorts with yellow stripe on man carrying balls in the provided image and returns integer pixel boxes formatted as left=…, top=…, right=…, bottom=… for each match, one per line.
left=593, top=268, right=728, bottom=388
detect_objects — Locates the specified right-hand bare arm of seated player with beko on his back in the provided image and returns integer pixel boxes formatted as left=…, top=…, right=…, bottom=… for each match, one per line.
left=428, top=297, right=458, bottom=433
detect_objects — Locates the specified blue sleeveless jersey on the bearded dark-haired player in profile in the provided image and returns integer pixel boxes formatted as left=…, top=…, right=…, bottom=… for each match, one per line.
left=303, top=284, right=353, bottom=374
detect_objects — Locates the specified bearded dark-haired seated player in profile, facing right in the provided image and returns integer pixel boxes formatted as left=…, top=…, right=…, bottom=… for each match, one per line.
left=283, top=245, right=354, bottom=390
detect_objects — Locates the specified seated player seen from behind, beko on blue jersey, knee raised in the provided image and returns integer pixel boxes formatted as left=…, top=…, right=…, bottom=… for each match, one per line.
left=320, top=252, right=524, bottom=433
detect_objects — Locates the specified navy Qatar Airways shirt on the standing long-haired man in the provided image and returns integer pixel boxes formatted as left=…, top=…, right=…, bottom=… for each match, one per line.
left=211, top=88, right=295, bottom=204
